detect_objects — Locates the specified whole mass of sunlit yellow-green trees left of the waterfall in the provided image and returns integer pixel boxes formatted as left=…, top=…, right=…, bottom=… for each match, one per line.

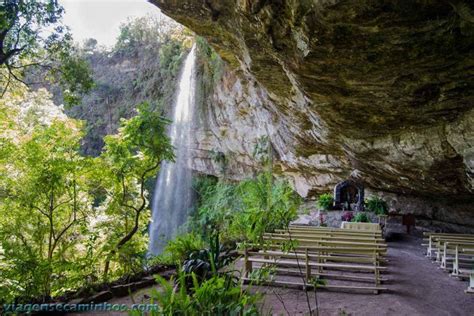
left=0, top=91, right=173, bottom=303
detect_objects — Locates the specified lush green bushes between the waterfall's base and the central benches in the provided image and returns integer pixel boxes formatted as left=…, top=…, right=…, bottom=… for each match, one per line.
left=194, top=173, right=301, bottom=242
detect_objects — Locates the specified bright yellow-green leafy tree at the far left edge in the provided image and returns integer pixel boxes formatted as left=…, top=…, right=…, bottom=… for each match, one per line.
left=0, top=91, right=93, bottom=298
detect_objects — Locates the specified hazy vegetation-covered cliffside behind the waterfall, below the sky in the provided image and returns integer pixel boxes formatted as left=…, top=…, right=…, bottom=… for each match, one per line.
left=57, top=17, right=187, bottom=156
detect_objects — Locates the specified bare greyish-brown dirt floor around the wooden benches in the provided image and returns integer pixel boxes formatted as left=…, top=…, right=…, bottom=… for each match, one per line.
left=73, top=235, right=474, bottom=316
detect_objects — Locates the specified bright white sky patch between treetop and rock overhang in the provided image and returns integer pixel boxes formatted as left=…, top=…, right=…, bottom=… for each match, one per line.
left=59, top=0, right=161, bottom=47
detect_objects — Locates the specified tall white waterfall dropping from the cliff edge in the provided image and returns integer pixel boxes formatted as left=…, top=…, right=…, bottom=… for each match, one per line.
left=149, top=45, right=196, bottom=255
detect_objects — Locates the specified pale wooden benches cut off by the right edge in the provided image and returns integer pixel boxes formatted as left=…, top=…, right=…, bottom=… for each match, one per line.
left=423, top=232, right=474, bottom=293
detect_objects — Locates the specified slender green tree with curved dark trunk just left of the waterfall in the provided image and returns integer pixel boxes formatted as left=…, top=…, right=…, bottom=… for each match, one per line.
left=97, top=103, right=174, bottom=279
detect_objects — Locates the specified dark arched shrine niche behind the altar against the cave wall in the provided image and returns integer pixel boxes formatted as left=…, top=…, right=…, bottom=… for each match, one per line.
left=334, top=180, right=364, bottom=211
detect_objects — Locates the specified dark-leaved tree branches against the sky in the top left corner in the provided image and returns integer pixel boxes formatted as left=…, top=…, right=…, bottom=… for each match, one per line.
left=0, top=0, right=93, bottom=104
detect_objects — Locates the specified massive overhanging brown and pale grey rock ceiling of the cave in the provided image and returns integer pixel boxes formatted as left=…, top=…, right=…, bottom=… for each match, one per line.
left=151, top=0, right=474, bottom=231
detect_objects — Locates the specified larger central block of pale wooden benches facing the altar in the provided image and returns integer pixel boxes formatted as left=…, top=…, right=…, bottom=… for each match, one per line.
left=242, top=226, right=387, bottom=293
